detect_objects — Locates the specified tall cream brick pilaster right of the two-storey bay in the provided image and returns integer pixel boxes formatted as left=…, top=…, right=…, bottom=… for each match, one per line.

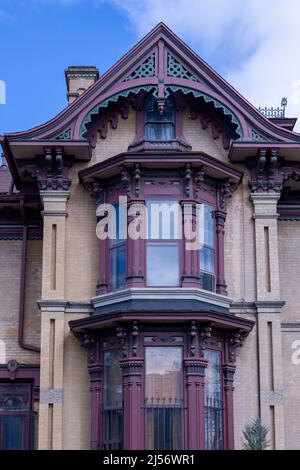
left=251, top=192, right=284, bottom=450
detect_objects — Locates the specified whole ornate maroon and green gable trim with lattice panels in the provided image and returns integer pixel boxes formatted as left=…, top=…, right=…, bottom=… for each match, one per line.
left=3, top=23, right=300, bottom=148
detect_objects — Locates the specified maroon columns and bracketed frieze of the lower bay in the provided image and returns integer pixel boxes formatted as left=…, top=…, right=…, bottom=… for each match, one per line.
left=70, top=312, right=253, bottom=450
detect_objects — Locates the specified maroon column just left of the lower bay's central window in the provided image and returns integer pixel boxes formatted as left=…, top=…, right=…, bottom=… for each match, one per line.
left=120, top=358, right=144, bottom=450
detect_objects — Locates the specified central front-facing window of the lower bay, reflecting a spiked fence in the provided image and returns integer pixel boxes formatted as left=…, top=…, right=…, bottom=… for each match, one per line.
left=145, top=346, right=183, bottom=450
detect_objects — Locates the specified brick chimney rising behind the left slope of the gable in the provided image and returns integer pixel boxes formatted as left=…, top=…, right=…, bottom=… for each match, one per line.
left=65, top=65, right=99, bottom=104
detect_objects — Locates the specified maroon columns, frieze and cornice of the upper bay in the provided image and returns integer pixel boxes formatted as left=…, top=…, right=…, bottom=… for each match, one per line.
left=80, top=152, right=242, bottom=295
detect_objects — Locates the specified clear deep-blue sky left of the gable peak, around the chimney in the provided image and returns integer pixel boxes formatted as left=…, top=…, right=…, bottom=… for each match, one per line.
left=0, top=0, right=137, bottom=133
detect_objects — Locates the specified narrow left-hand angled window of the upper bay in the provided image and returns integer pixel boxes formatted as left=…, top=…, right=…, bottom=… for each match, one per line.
left=109, top=204, right=126, bottom=290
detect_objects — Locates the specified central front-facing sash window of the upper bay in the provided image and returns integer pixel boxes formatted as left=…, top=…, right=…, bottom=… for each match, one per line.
left=146, top=199, right=180, bottom=287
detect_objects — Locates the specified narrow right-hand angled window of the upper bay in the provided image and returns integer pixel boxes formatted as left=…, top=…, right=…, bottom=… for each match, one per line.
left=200, top=203, right=215, bottom=292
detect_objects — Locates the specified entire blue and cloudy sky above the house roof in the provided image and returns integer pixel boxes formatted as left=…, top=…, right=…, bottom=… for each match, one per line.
left=0, top=0, right=300, bottom=134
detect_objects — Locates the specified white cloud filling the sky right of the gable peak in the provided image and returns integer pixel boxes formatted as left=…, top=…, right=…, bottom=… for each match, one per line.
left=105, top=0, right=300, bottom=129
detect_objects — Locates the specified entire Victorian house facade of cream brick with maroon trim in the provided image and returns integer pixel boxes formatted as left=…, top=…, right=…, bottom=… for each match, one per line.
left=0, top=24, right=300, bottom=450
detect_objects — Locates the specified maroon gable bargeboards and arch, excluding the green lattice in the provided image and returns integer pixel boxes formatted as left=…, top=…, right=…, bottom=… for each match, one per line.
left=1, top=23, right=299, bottom=148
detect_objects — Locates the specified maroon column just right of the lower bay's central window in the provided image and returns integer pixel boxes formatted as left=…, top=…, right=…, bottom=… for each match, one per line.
left=184, top=358, right=207, bottom=450
